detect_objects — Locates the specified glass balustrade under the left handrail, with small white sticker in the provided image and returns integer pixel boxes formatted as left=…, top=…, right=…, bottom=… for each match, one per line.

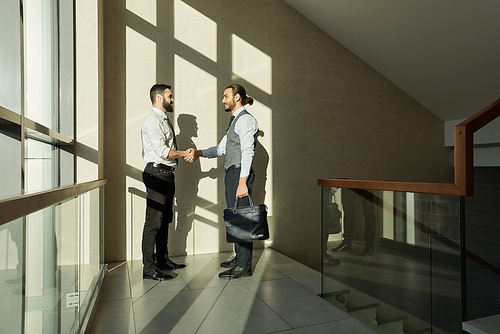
left=0, top=187, right=104, bottom=333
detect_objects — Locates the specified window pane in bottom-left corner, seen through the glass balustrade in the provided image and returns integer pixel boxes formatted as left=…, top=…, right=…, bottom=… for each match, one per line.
left=0, top=218, right=24, bottom=333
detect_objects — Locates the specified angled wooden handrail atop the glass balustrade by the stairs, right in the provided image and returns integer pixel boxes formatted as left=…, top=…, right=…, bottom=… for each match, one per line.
left=318, top=99, right=500, bottom=196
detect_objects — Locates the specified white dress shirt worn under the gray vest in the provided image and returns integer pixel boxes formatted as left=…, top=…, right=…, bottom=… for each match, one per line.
left=202, top=107, right=259, bottom=177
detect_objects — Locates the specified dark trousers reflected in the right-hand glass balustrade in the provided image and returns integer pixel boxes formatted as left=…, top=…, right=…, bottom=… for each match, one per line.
left=342, top=188, right=375, bottom=249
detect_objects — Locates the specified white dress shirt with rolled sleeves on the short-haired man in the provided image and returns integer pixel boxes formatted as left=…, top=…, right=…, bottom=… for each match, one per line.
left=141, top=107, right=176, bottom=167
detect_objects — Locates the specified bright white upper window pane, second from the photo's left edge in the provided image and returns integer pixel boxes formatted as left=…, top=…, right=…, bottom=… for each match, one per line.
left=24, top=0, right=59, bottom=131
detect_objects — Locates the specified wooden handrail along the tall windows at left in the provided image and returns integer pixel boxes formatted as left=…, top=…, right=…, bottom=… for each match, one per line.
left=0, top=179, right=107, bottom=226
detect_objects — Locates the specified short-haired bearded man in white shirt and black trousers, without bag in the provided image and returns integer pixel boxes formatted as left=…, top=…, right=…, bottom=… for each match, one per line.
left=141, top=84, right=195, bottom=281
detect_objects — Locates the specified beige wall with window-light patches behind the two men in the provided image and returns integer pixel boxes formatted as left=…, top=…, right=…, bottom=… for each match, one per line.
left=97, top=0, right=453, bottom=267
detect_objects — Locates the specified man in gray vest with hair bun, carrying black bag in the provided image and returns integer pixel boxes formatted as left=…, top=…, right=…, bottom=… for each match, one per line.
left=196, top=84, right=259, bottom=279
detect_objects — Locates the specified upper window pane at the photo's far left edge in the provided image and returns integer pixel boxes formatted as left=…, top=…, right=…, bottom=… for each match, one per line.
left=0, top=1, right=22, bottom=114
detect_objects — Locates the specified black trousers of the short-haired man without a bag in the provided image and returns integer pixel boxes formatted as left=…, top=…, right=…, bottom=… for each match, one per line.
left=142, top=163, right=175, bottom=271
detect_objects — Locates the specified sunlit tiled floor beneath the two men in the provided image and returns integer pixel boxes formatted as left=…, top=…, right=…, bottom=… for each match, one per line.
left=91, top=249, right=375, bottom=334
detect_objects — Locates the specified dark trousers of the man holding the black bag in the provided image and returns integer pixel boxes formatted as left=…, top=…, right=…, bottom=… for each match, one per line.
left=228, top=168, right=255, bottom=268
